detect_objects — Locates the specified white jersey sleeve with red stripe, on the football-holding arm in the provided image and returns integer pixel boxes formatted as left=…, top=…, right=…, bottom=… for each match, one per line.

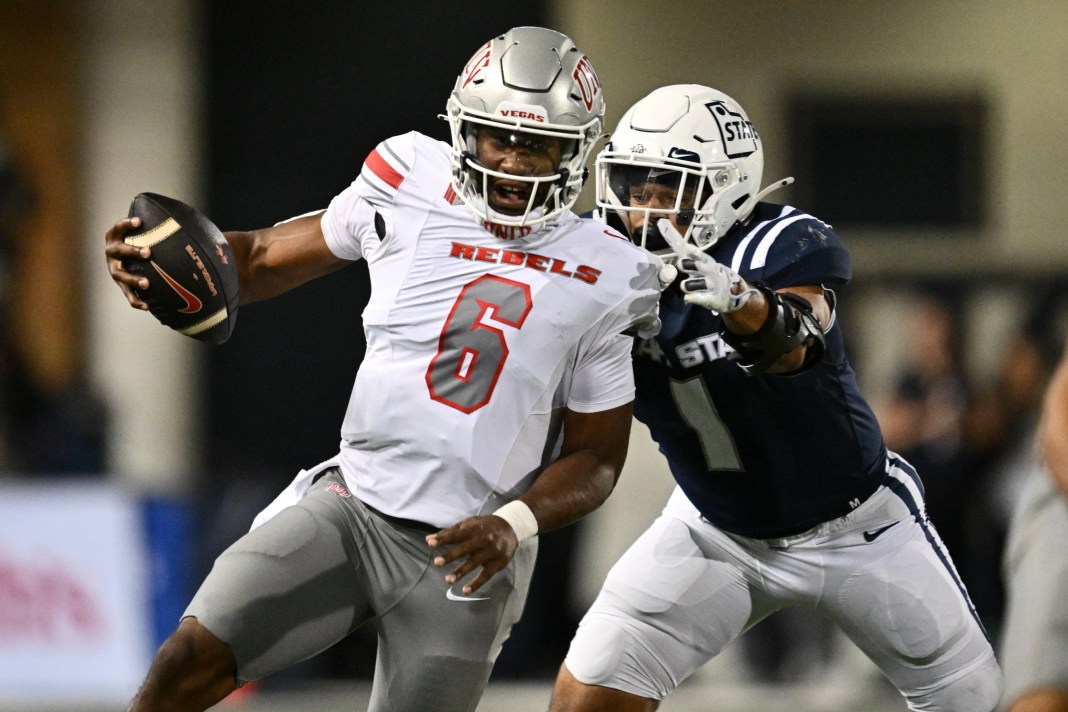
left=323, top=133, right=415, bottom=259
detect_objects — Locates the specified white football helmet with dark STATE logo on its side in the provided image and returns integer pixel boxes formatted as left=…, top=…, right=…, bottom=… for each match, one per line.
left=596, top=84, right=794, bottom=256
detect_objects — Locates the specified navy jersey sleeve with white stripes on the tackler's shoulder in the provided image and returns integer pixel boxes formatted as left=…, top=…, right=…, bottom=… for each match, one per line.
left=734, top=209, right=852, bottom=289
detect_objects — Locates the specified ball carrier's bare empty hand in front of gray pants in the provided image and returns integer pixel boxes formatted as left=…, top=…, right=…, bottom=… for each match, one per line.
left=426, top=516, right=519, bottom=595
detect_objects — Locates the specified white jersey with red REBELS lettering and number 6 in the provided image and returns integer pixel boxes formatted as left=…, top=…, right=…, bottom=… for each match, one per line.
left=261, top=132, right=659, bottom=527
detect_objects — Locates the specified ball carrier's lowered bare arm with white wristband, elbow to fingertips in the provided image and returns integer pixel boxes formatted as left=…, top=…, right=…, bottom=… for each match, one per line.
left=426, top=404, right=633, bottom=594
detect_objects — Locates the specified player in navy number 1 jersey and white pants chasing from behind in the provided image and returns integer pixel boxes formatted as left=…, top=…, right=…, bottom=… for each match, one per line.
left=552, top=85, right=1002, bottom=712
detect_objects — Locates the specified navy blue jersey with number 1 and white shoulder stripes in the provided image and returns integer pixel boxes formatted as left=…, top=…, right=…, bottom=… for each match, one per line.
left=634, top=203, right=885, bottom=538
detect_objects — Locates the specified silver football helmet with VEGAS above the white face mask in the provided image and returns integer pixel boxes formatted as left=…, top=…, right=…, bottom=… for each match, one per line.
left=445, top=27, right=604, bottom=225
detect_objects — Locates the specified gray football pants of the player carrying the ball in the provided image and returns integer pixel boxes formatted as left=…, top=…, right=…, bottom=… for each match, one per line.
left=185, top=469, right=537, bottom=712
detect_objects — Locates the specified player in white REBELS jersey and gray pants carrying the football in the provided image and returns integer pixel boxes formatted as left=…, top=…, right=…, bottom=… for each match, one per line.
left=106, top=28, right=660, bottom=710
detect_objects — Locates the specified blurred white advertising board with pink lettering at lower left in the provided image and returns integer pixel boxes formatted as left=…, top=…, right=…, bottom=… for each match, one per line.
left=0, top=478, right=160, bottom=709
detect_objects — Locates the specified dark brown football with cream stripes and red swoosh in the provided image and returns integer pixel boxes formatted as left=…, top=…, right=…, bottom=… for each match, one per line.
left=124, top=193, right=239, bottom=344
